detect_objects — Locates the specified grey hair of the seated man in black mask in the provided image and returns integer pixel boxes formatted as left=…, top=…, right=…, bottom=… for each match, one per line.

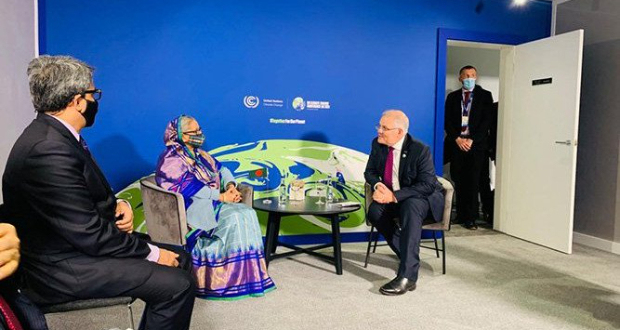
left=28, top=55, right=95, bottom=112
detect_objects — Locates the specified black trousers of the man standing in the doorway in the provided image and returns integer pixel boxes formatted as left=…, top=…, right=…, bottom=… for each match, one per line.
left=450, top=149, right=485, bottom=224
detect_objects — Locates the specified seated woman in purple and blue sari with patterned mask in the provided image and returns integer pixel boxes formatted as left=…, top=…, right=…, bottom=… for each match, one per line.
left=155, top=115, right=275, bottom=299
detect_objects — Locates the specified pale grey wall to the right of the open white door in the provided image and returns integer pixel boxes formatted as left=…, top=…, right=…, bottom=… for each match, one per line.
left=556, top=0, right=620, bottom=249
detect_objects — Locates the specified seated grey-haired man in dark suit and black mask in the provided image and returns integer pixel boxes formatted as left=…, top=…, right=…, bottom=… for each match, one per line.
left=2, top=56, right=195, bottom=330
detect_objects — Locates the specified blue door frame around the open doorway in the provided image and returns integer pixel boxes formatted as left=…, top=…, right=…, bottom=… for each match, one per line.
left=433, top=28, right=532, bottom=176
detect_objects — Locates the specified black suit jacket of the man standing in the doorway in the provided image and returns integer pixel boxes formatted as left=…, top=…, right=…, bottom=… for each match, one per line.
left=444, top=85, right=493, bottom=159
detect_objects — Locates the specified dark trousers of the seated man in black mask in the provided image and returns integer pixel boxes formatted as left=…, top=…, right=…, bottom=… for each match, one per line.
left=25, top=242, right=196, bottom=330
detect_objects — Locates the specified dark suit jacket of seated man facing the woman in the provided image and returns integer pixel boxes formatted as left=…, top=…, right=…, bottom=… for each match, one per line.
left=364, top=134, right=444, bottom=221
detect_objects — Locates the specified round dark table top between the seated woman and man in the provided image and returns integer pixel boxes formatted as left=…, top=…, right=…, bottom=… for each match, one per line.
left=252, top=196, right=361, bottom=215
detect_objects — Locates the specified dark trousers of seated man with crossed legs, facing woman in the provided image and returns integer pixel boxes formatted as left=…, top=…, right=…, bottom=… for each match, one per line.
left=368, top=198, right=430, bottom=282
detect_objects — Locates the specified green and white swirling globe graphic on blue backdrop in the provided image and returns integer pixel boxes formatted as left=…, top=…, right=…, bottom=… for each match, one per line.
left=118, top=140, right=368, bottom=235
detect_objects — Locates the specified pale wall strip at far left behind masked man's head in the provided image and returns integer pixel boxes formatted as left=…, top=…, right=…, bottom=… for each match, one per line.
left=0, top=0, right=38, bottom=203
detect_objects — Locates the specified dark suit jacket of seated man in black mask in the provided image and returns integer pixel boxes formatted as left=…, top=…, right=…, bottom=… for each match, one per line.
left=2, top=114, right=150, bottom=303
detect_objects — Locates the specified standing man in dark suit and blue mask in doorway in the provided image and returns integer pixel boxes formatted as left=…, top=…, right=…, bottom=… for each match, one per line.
left=444, top=65, right=493, bottom=229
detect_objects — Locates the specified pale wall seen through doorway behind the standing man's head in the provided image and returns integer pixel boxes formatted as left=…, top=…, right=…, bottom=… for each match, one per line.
left=446, top=45, right=499, bottom=101
